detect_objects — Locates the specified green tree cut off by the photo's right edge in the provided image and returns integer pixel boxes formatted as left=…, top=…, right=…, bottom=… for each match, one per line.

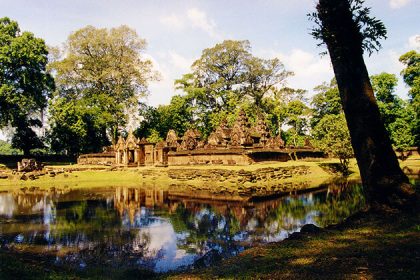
left=400, top=51, right=420, bottom=147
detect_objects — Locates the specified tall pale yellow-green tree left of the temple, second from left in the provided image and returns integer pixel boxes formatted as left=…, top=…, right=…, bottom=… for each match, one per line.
left=51, top=25, right=157, bottom=150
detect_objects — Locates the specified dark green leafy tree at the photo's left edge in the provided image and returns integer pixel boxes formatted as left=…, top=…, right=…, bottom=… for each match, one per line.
left=0, top=18, right=54, bottom=155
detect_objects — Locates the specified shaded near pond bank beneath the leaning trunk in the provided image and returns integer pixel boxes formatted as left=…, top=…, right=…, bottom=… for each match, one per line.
left=167, top=207, right=420, bottom=279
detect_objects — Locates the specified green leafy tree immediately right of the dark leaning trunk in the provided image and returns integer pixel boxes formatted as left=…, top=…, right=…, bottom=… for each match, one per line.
left=370, top=73, right=414, bottom=149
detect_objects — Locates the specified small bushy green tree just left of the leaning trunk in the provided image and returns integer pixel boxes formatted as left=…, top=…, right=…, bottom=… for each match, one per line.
left=312, top=113, right=353, bottom=175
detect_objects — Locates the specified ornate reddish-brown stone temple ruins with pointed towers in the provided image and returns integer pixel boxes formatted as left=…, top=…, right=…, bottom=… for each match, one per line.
left=78, top=111, right=324, bottom=166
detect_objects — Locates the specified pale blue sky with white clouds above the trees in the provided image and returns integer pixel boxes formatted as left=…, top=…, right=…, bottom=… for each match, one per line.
left=0, top=0, right=420, bottom=139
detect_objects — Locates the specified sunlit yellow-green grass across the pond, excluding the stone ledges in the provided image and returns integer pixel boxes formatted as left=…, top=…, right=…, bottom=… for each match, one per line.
left=0, top=157, right=420, bottom=191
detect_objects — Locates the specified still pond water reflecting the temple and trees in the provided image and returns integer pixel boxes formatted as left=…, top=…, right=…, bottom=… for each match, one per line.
left=0, top=183, right=364, bottom=272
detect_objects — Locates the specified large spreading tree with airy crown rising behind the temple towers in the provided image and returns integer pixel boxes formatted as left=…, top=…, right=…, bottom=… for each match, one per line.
left=175, top=40, right=292, bottom=137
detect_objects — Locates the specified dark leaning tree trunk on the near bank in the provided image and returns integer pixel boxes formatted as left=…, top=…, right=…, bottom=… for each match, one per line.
left=317, top=0, right=414, bottom=206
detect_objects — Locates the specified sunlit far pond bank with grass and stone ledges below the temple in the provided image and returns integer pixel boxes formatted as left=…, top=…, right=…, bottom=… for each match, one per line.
left=0, top=161, right=344, bottom=194
